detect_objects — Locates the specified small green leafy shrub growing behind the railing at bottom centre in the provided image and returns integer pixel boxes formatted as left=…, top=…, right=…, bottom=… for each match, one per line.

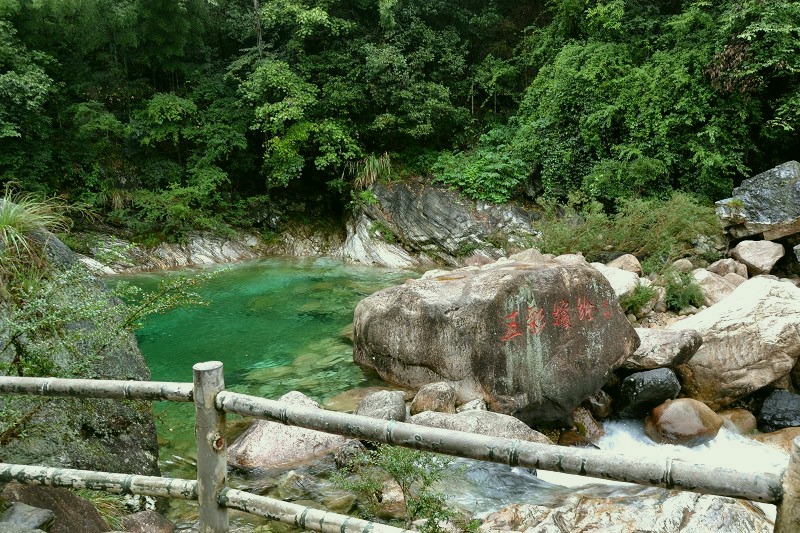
left=333, top=444, right=457, bottom=533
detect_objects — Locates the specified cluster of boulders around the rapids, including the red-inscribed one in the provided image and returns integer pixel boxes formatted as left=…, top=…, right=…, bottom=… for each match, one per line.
left=225, top=163, right=800, bottom=531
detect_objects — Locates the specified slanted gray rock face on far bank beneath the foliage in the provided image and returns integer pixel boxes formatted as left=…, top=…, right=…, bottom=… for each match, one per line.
left=348, top=182, right=537, bottom=266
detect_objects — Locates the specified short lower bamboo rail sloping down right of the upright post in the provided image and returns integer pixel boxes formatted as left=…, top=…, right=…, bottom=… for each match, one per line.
left=219, top=488, right=407, bottom=533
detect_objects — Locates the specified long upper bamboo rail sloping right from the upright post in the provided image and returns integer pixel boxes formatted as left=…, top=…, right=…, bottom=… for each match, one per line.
left=217, top=391, right=782, bottom=503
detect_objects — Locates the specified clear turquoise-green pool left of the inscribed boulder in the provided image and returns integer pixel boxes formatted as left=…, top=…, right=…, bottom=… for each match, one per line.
left=123, top=258, right=418, bottom=478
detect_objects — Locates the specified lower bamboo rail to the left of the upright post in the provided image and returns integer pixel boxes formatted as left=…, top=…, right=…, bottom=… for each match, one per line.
left=0, top=463, right=197, bottom=500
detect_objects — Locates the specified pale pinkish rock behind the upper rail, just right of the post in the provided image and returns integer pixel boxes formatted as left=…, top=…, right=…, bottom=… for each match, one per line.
left=228, top=391, right=347, bottom=468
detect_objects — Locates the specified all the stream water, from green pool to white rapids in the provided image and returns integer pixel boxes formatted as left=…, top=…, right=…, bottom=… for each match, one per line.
left=121, top=258, right=787, bottom=531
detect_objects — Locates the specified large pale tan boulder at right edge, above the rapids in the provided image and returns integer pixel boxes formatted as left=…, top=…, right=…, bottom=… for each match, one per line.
left=668, top=276, right=800, bottom=409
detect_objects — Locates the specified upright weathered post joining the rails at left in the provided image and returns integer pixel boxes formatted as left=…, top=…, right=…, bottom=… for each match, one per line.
left=192, top=361, right=228, bottom=533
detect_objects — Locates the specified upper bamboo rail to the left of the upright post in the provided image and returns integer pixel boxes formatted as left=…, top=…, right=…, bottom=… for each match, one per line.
left=0, top=377, right=194, bottom=402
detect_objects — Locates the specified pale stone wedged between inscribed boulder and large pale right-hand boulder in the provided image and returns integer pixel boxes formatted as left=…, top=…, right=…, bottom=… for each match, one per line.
left=622, top=328, right=703, bottom=370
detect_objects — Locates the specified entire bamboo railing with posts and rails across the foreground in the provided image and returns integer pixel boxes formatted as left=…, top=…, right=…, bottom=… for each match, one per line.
left=0, top=361, right=800, bottom=533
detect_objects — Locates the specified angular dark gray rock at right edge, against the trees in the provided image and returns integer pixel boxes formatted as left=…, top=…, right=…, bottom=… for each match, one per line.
left=716, top=161, right=800, bottom=240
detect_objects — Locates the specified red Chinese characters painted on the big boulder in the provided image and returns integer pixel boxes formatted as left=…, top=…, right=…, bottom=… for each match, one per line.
left=502, top=295, right=611, bottom=342
